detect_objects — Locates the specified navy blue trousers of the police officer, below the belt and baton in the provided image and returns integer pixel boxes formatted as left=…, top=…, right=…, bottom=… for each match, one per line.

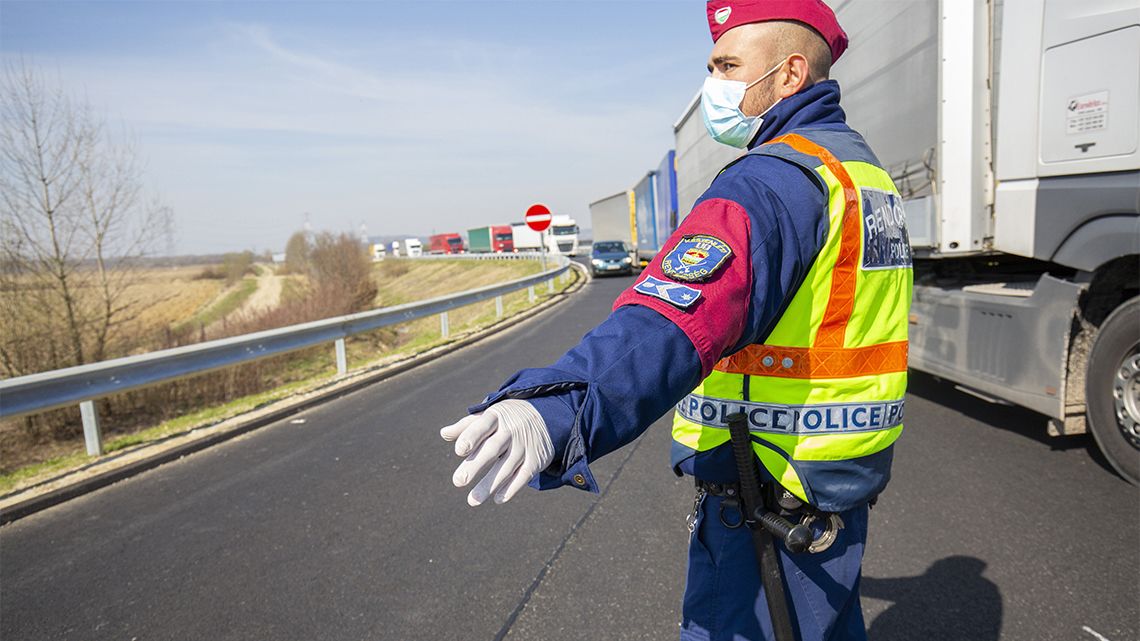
left=681, top=496, right=868, bottom=641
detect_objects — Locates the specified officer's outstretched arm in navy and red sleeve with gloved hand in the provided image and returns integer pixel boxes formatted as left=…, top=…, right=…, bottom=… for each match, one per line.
left=442, top=159, right=827, bottom=505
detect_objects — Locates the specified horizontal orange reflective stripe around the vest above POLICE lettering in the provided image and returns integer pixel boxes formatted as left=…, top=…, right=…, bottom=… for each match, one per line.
left=714, top=341, right=906, bottom=379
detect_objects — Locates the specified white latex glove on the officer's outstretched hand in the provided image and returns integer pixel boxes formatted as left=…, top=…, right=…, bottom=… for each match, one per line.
left=439, top=398, right=554, bottom=506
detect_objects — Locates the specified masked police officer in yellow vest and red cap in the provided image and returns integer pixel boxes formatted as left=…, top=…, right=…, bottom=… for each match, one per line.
left=441, top=0, right=912, bottom=641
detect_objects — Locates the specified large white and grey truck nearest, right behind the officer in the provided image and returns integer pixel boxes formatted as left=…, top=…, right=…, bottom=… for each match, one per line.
left=674, top=0, right=1140, bottom=484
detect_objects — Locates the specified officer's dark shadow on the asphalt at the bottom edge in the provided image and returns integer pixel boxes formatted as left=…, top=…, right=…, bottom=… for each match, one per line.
left=860, top=557, right=1002, bottom=641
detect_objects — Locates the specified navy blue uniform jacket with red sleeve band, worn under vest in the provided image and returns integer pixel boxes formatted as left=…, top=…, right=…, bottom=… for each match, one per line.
left=471, top=80, right=847, bottom=492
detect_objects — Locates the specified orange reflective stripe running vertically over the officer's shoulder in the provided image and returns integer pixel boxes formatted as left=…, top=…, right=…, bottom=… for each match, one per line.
left=770, top=133, right=861, bottom=348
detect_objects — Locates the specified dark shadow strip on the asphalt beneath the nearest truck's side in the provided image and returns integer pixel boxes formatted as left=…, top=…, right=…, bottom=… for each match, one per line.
left=906, top=370, right=1116, bottom=474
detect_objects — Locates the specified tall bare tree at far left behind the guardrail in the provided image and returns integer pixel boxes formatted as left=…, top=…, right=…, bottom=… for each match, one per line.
left=0, top=63, right=170, bottom=376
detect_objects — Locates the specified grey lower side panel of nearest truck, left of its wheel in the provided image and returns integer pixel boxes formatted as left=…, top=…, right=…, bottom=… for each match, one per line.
left=909, top=274, right=1085, bottom=420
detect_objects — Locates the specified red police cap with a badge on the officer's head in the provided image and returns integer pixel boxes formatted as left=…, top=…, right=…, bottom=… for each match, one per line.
left=708, top=0, right=847, bottom=63
